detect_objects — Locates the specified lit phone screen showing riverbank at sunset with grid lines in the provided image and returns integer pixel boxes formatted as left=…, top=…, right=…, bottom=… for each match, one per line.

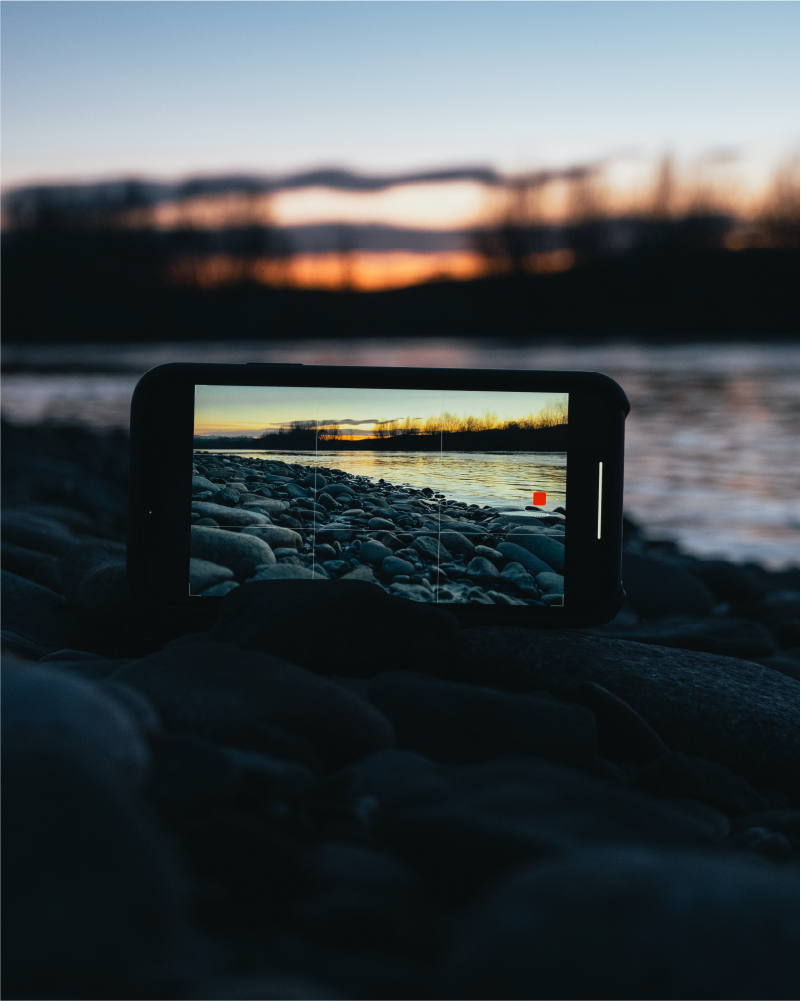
left=188, top=385, right=569, bottom=608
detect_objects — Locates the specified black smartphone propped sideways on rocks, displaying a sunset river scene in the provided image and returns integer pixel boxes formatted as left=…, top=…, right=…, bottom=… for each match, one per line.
left=128, top=364, right=629, bottom=627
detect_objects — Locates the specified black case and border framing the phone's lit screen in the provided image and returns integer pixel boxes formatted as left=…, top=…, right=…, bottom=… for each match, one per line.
left=128, top=364, right=629, bottom=628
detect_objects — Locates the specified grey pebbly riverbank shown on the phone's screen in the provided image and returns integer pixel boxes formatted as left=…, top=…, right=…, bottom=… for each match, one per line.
left=190, top=451, right=566, bottom=606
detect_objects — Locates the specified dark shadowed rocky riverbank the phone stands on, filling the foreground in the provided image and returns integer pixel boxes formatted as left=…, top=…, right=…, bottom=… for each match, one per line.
left=0, top=425, right=799, bottom=1001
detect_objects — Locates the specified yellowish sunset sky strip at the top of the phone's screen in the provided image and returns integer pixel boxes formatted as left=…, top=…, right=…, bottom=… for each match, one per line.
left=194, top=385, right=565, bottom=434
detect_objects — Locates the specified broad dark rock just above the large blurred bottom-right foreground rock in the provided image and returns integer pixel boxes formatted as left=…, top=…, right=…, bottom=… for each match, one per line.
left=376, top=752, right=719, bottom=904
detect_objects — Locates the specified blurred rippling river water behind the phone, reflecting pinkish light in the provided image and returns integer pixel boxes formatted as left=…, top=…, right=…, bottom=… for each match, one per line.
left=0, top=339, right=799, bottom=568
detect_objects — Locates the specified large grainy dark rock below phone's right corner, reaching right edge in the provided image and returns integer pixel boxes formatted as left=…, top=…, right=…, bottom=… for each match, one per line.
left=460, top=627, right=798, bottom=795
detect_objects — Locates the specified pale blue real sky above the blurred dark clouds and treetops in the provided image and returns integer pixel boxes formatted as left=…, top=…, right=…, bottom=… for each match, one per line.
left=0, top=0, right=799, bottom=194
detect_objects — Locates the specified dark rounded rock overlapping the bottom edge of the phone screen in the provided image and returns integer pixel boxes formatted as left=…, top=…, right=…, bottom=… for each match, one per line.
left=203, top=580, right=459, bottom=678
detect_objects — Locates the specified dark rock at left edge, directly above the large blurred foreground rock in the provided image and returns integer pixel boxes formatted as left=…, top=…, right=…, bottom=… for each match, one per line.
left=0, top=570, right=97, bottom=658
